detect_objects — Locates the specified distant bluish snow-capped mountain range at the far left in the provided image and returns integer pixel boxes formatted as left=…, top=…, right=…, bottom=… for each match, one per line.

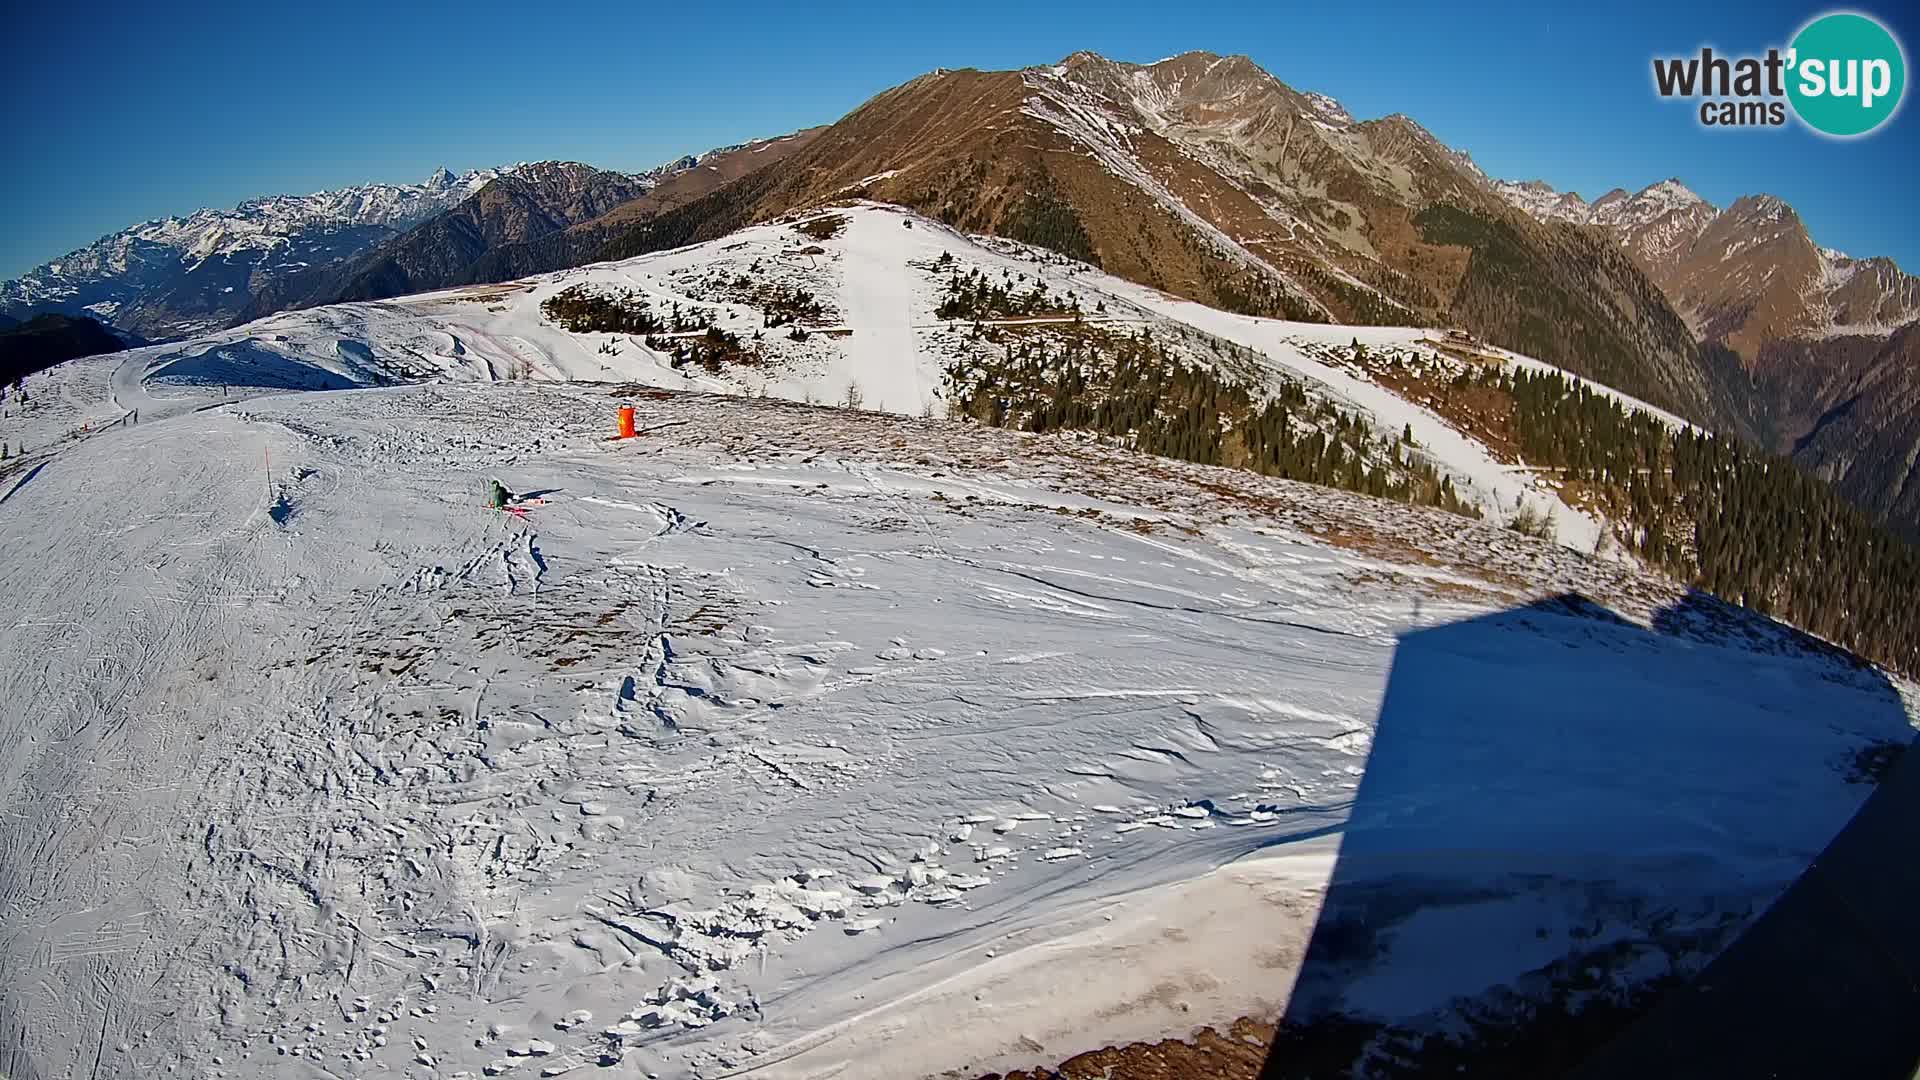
left=0, top=169, right=499, bottom=338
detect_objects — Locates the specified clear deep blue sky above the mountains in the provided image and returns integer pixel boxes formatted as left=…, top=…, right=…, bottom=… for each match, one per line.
left=0, top=0, right=1920, bottom=277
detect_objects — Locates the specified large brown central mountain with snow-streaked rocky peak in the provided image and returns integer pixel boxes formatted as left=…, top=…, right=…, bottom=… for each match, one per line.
left=601, top=52, right=1732, bottom=423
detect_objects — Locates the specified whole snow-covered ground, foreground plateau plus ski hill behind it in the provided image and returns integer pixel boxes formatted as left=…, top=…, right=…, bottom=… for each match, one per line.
left=0, top=204, right=1916, bottom=1080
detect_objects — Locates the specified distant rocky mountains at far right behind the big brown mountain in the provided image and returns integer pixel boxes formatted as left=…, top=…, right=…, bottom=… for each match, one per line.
left=1498, top=179, right=1920, bottom=536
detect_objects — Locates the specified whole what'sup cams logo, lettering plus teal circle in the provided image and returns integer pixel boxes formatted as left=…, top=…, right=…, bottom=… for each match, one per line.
left=1653, top=12, right=1907, bottom=138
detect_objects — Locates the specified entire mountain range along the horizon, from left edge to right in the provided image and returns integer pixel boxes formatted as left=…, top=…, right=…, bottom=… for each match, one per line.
left=0, top=52, right=1920, bottom=534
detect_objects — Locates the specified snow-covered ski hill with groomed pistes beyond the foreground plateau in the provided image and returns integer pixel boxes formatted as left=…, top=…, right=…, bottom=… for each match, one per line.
left=37, top=204, right=1697, bottom=552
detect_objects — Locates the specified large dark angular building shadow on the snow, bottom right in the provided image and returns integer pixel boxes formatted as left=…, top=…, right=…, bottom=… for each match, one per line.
left=1261, top=594, right=1920, bottom=1078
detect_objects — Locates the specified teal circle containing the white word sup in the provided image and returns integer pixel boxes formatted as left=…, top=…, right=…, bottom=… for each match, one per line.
left=1788, top=12, right=1907, bottom=138
